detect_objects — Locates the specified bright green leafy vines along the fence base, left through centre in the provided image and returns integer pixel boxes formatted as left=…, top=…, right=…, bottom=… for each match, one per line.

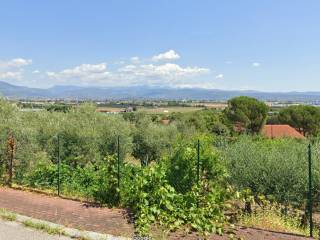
left=24, top=137, right=229, bottom=235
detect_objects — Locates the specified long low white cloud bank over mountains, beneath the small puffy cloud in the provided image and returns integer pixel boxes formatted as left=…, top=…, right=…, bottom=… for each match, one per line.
left=47, top=63, right=210, bottom=86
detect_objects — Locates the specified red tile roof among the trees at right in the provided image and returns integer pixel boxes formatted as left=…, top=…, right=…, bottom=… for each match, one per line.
left=261, top=125, right=305, bottom=139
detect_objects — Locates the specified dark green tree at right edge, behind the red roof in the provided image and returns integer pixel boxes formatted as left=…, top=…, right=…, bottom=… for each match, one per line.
left=278, top=105, right=320, bottom=136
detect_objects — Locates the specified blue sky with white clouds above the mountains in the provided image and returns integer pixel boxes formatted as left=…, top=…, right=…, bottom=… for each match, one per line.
left=0, top=0, right=320, bottom=91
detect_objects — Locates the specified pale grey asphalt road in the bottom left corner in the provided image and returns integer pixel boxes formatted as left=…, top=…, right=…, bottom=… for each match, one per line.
left=0, top=220, right=71, bottom=240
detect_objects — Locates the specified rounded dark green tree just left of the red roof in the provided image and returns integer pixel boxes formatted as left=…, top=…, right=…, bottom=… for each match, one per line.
left=224, top=97, right=269, bottom=133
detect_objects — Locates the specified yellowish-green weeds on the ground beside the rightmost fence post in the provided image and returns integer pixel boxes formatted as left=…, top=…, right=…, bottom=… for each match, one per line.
left=239, top=209, right=318, bottom=236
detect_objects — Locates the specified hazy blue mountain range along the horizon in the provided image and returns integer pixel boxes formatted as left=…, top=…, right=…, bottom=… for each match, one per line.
left=0, top=81, right=320, bottom=102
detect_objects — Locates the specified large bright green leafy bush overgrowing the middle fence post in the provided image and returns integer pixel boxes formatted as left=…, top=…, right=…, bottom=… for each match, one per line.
left=127, top=137, right=228, bottom=234
